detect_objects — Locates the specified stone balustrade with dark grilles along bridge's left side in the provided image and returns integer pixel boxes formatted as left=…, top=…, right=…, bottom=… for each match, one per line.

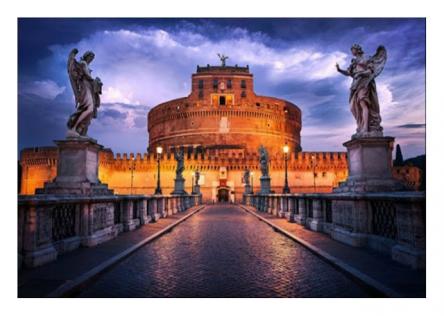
left=18, top=195, right=201, bottom=267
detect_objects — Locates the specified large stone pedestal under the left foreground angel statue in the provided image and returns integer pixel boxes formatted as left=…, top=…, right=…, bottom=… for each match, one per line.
left=36, top=137, right=113, bottom=195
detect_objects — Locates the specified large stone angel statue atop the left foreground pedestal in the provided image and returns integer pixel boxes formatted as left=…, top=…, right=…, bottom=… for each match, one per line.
left=67, top=48, right=102, bottom=137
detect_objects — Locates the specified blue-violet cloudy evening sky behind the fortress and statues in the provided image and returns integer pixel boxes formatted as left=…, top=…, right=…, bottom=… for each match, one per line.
left=18, top=18, right=425, bottom=158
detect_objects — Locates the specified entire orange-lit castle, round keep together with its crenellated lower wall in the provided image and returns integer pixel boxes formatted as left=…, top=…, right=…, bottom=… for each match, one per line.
left=20, top=61, right=419, bottom=202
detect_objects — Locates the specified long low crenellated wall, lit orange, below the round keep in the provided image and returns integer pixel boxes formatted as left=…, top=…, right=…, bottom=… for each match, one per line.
left=20, top=147, right=354, bottom=201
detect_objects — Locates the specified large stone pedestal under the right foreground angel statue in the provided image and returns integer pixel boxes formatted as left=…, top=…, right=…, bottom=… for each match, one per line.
left=334, top=137, right=405, bottom=192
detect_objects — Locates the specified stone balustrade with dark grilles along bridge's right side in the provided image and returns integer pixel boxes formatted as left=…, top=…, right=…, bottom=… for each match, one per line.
left=243, top=192, right=426, bottom=268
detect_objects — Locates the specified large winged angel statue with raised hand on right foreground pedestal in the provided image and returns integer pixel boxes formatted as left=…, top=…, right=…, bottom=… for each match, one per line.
left=336, top=44, right=387, bottom=138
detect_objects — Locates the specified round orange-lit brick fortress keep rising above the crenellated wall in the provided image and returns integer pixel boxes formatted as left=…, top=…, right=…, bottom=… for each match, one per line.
left=147, top=65, right=301, bottom=154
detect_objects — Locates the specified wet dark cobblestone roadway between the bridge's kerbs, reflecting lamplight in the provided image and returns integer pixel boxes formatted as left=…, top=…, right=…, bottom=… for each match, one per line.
left=79, top=204, right=372, bottom=297
